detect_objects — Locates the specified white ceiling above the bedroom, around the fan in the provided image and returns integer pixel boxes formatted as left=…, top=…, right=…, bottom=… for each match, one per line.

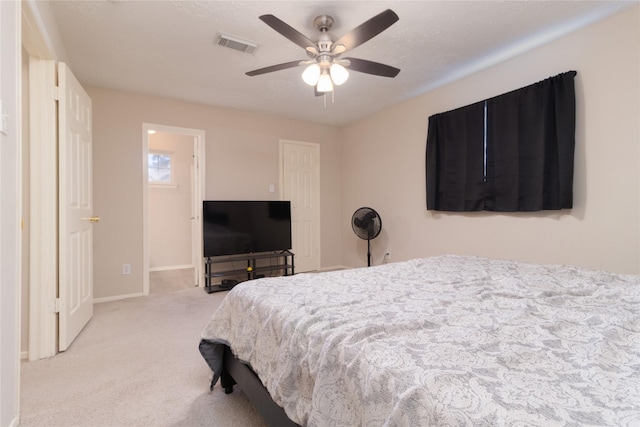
left=49, top=0, right=637, bottom=125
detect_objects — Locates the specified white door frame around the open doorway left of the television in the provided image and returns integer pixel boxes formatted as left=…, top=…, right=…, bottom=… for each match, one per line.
left=142, top=123, right=206, bottom=295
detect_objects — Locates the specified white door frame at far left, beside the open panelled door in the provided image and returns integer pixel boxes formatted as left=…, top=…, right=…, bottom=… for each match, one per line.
left=20, top=2, right=58, bottom=361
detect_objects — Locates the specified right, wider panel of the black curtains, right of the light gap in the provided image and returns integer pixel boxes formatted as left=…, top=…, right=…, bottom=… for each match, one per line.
left=485, top=71, right=576, bottom=212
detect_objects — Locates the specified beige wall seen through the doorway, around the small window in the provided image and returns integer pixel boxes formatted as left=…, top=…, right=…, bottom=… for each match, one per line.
left=147, top=132, right=194, bottom=270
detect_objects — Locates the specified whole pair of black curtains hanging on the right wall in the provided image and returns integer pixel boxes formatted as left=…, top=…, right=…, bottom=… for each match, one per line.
left=427, top=71, right=576, bottom=212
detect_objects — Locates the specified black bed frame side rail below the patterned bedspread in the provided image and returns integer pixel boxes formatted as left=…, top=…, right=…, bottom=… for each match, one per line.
left=220, top=346, right=300, bottom=427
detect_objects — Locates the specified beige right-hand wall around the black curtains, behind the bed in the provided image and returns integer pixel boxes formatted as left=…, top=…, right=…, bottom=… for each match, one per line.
left=342, top=7, right=640, bottom=273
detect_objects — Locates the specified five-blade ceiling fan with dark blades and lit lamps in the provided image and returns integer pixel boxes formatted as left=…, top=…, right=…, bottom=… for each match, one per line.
left=246, top=9, right=400, bottom=95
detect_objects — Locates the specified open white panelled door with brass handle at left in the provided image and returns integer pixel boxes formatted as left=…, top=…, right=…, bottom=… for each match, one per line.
left=58, top=63, right=93, bottom=351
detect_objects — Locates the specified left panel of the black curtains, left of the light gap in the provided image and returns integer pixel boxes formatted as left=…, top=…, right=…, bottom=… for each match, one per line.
left=427, top=102, right=485, bottom=211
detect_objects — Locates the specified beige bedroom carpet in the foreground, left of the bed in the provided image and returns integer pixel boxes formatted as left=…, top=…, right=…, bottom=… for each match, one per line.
left=20, top=288, right=266, bottom=427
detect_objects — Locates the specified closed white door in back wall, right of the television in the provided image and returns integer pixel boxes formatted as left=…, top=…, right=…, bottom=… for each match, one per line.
left=281, top=141, right=320, bottom=273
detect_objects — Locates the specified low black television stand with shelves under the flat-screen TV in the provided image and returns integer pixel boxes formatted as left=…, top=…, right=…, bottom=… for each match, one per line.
left=204, top=251, right=295, bottom=294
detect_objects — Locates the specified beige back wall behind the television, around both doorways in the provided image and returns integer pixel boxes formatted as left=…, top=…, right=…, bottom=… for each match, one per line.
left=85, top=87, right=342, bottom=298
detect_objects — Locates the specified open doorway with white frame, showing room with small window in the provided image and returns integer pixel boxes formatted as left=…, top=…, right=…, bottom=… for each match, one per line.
left=142, top=123, right=205, bottom=295
